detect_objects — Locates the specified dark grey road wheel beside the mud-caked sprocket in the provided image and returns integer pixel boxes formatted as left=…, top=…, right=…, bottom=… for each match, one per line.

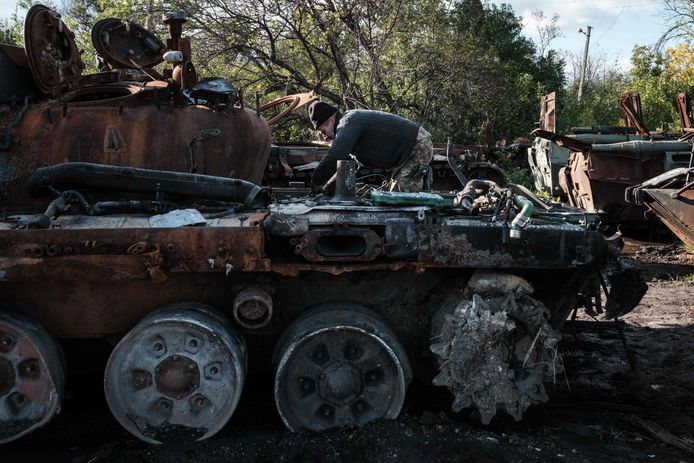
left=274, top=303, right=412, bottom=431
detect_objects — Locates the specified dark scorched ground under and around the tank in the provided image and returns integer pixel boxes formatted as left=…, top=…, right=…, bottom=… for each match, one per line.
left=0, top=244, right=694, bottom=463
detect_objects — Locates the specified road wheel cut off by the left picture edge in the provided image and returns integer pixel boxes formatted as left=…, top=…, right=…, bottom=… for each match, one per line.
left=0, top=313, right=65, bottom=444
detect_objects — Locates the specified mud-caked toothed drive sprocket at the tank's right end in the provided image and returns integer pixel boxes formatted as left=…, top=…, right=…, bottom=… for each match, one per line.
left=431, top=273, right=561, bottom=424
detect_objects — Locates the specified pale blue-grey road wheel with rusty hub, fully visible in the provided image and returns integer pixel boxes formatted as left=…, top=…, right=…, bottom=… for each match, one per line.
left=104, top=303, right=247, bottom=444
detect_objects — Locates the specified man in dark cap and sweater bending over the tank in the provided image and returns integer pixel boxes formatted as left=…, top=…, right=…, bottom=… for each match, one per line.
left=308, top=101, right=434, bottom=192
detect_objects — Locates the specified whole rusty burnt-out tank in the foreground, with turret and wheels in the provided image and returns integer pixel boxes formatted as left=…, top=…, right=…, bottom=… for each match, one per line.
left=0, top=6, right=644, bottom=443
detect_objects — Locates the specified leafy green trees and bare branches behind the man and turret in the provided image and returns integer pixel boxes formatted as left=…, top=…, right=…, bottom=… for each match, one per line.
left=6, top=0, right=565, bottom=143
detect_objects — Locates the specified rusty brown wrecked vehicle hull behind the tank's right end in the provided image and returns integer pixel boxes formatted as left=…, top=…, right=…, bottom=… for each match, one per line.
left=533, top=94, right=690, bottom=231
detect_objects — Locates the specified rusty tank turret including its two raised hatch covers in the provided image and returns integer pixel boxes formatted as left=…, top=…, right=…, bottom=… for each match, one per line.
left=0, top=6, right=270, bottom=209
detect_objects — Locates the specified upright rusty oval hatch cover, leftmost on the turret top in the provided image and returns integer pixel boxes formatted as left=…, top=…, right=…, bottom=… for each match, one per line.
left=24, top=5, right=84, bottom=96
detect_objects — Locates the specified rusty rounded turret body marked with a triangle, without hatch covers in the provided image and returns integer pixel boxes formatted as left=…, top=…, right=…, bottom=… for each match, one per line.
left=0, top=82, right=271, bottom=209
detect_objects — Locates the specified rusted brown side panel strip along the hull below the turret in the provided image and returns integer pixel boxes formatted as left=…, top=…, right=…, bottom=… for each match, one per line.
left=0, top=221, right=270, bottom=282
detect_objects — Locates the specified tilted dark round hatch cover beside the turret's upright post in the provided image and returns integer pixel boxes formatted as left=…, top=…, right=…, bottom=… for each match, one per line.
left=92, top=18, right=166, bottom=68
